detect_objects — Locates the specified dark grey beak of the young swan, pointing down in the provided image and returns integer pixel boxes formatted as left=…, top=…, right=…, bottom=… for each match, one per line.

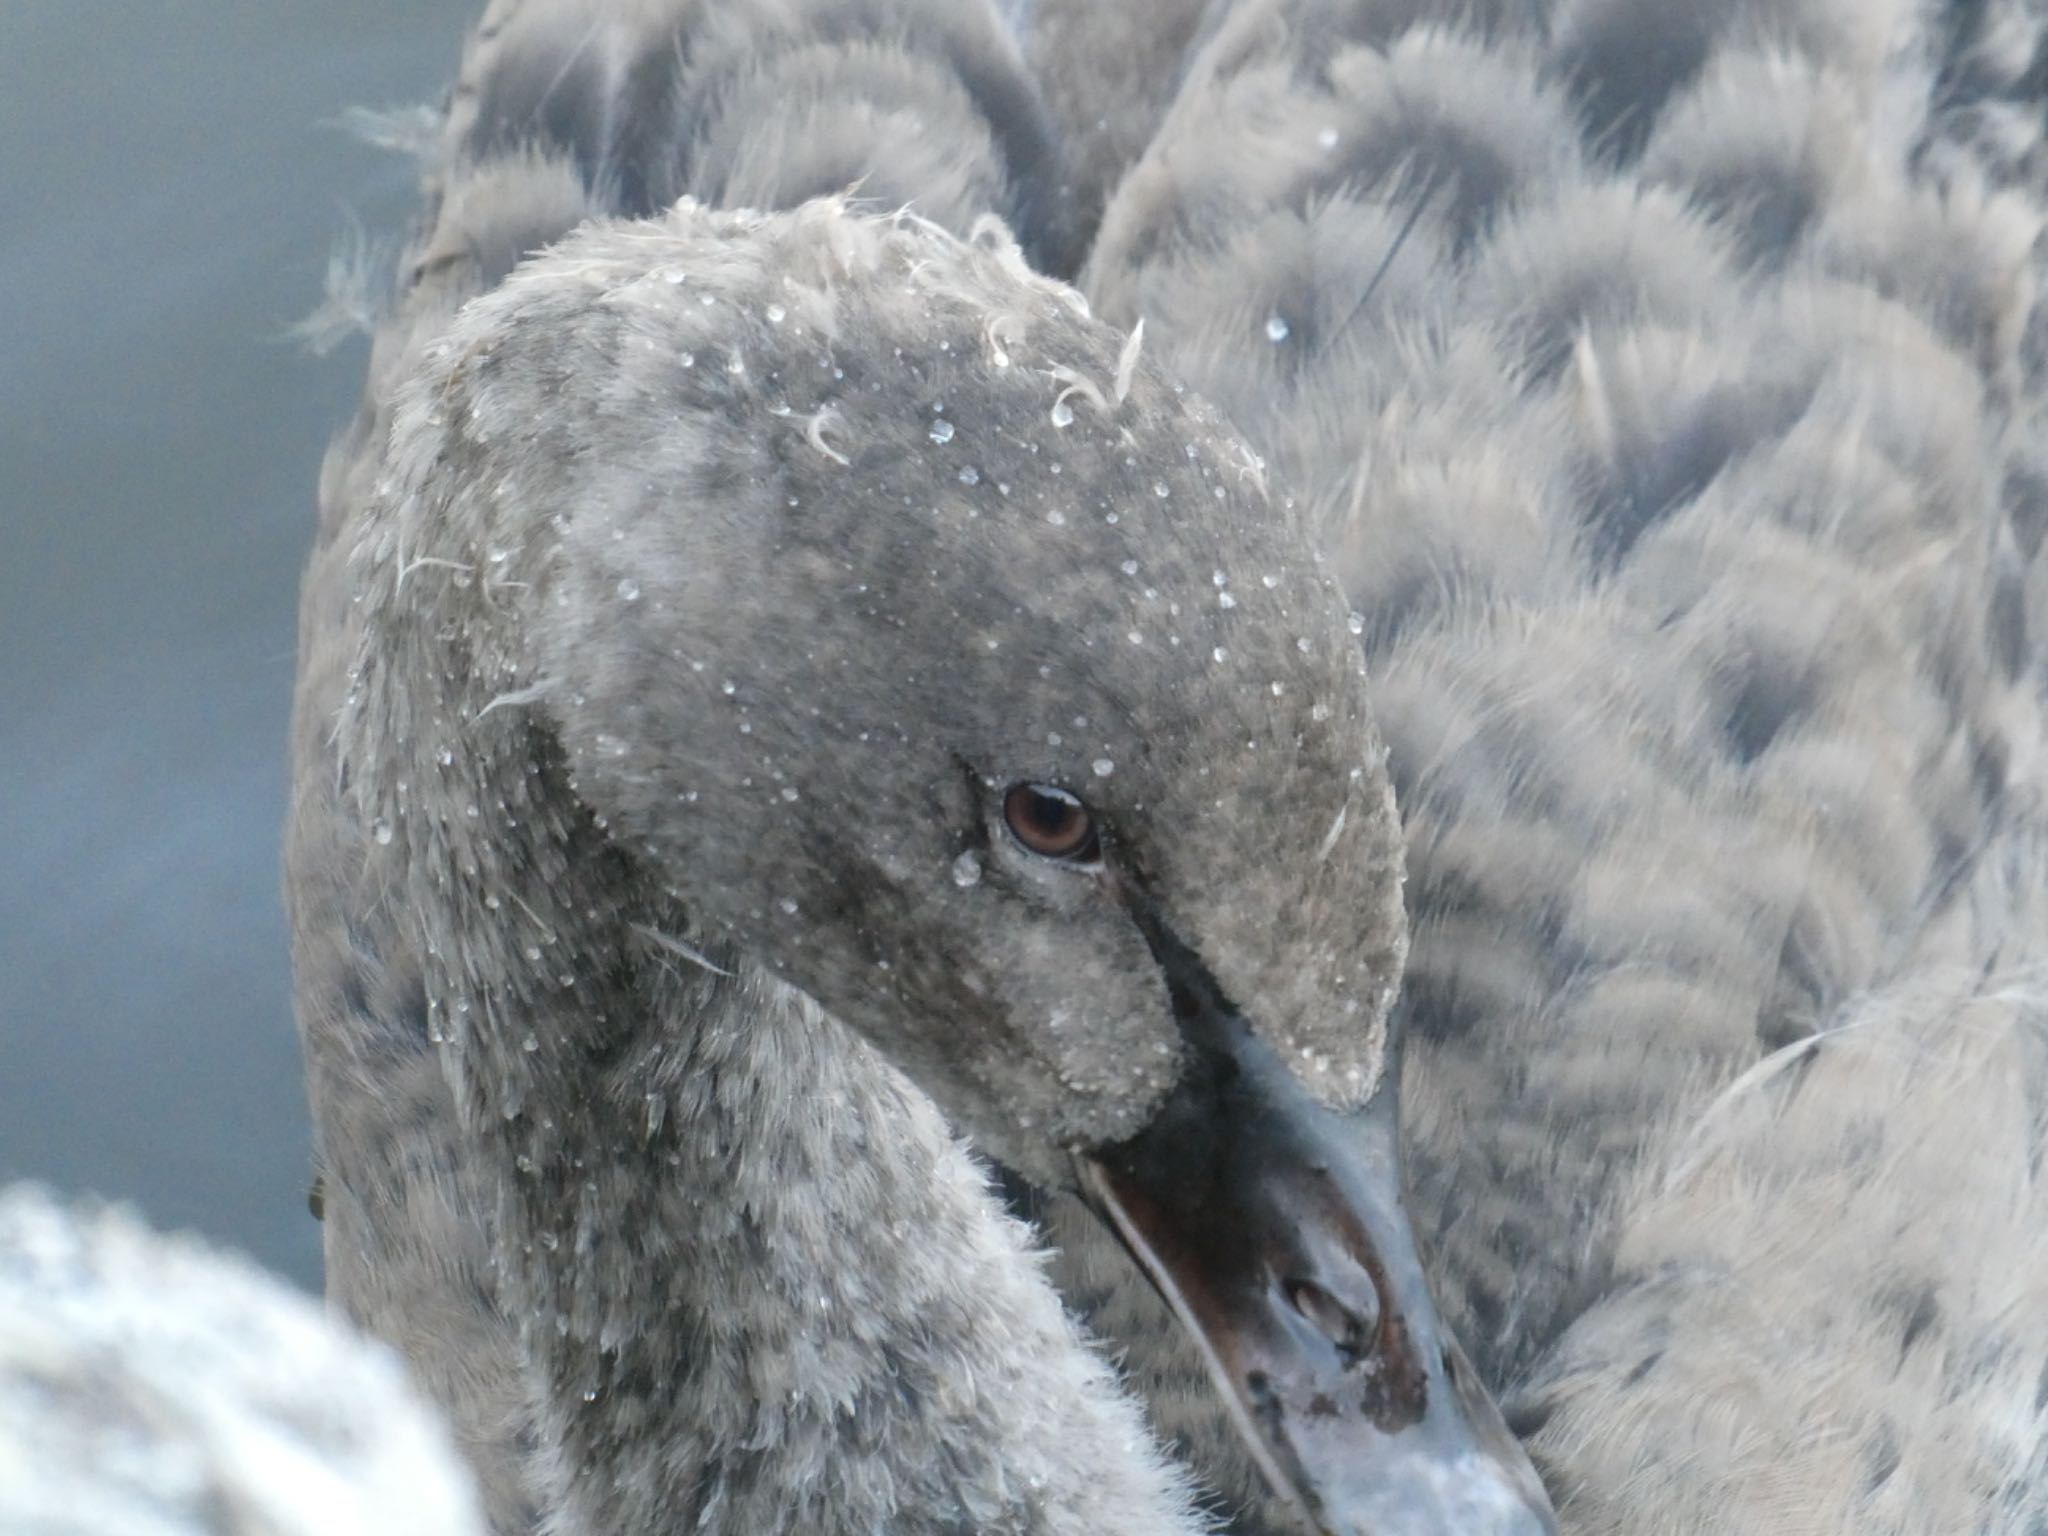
left=1079, top=1016, right=1556, bottom=1536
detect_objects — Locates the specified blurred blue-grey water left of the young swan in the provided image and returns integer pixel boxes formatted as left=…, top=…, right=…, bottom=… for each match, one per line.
left=0, top=0, right=481, bottom=1284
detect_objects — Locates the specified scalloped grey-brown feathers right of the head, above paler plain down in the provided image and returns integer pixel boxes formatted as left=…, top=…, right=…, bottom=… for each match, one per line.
left=1085, top=0, right=2040, bottom=1374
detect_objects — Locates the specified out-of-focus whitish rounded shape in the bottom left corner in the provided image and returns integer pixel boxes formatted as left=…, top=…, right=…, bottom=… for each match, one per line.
left=0, top=1186, right=483, bottom=1536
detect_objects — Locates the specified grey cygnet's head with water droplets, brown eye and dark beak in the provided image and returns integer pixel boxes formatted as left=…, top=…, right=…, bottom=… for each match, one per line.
left=365, top=203, right=1544, bottom=1532
